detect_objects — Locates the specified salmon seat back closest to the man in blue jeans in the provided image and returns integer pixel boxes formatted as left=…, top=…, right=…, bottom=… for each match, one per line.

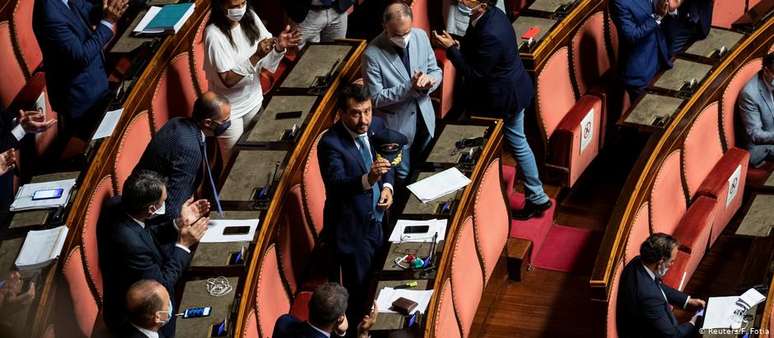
left=536, top=47, right=575, bottom=141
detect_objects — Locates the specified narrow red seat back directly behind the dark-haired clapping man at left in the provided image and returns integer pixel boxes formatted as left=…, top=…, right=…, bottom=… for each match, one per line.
left=81, top=175, right=113, bottom=304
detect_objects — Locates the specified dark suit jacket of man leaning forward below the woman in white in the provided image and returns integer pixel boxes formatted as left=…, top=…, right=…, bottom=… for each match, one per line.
left=134, top=117, right=204, bottom=220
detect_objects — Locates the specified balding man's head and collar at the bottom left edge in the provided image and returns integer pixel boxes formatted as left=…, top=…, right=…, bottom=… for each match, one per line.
left=119, top=279, right=174, bottom=338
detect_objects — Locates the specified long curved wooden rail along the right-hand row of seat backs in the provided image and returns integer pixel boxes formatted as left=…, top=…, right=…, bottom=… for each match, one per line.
left=589, top=19, right=774, bottom=301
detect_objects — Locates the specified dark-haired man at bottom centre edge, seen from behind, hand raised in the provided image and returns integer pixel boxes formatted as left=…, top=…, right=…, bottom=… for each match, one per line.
left=272, top=283, right=378, bottom=338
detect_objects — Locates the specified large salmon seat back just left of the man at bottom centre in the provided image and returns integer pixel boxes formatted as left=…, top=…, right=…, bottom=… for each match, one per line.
left=255, top=244, right=290, bottom=338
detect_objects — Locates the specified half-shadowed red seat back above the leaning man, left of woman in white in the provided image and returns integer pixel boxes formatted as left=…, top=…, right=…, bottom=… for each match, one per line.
left=151, top=52, right=198, bottom=133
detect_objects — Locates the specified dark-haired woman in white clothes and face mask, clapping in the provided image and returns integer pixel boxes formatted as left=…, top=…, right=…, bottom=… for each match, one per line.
left=204, top=0, right=301, bottom=164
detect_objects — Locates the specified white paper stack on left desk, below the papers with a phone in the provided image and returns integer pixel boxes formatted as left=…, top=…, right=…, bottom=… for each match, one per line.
left=15, top=225, right=68, bottom=270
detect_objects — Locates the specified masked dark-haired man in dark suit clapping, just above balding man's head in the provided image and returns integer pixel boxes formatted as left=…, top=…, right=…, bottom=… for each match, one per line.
left=97, top=171, right=210, bottom=337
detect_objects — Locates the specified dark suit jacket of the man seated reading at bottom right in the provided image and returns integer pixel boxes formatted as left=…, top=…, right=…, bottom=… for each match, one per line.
left=616, top=256, right=695, bottom=338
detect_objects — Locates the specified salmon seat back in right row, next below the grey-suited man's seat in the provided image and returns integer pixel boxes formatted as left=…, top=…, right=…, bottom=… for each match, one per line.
left=681, top=101, right=723, bottom=198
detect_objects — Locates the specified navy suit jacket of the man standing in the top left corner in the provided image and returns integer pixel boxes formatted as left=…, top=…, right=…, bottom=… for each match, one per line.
left=33, top=0, right=113, bottom=118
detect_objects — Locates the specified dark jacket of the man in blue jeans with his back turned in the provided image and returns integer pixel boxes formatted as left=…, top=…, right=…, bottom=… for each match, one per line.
left=446, top=9, right=535, bottom=117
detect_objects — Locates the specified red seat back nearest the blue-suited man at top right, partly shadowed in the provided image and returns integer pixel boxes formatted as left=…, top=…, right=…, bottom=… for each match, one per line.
left=570, top=11, right=611, bottom=95
